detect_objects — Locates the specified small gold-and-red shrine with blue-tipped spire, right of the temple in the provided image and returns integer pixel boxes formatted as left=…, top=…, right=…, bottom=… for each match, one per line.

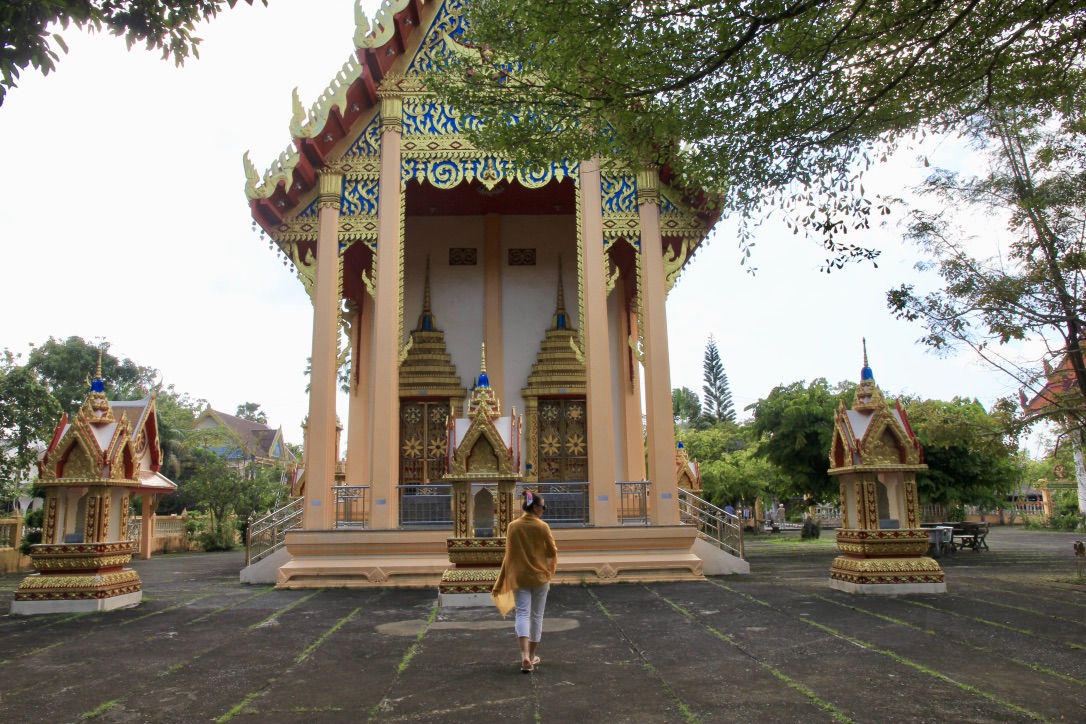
left=829, top=341, right=946, bottom=594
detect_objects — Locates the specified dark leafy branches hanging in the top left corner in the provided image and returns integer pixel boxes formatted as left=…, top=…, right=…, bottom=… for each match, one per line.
left=0, top=0, right=267, bottom=105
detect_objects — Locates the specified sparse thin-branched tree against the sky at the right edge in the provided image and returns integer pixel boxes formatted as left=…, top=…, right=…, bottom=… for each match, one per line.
left=887, top=103, right=1086, bottom=510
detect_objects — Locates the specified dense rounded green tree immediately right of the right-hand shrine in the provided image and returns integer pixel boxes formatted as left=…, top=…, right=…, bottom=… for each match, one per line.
left=906, top=397, right=1023, bottom=506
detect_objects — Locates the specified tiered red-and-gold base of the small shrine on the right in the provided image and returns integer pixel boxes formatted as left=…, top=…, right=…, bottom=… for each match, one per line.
left=830, top=529, right=947, bottom=596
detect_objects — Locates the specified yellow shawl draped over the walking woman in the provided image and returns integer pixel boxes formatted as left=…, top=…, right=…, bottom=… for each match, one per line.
left=490, top=512, right=558, bottom=617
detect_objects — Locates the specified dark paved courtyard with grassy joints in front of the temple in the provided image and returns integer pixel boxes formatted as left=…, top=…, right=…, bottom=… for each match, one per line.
left=0, top=528, right=1086, bottom=723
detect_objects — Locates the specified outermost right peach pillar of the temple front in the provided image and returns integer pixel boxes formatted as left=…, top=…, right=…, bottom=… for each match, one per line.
left=637, top=169, right=679, bottom=525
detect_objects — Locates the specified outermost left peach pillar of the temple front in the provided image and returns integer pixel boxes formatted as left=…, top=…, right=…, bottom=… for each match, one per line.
left=302, top=170, right=343, bottom=530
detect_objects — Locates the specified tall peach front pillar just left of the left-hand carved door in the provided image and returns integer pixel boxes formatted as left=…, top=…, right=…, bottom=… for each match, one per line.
left=369, top=98, right=403, bottom=529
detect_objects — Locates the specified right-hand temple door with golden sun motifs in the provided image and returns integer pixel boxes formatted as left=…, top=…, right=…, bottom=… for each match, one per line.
left=538, top=397, right=589, bottom=483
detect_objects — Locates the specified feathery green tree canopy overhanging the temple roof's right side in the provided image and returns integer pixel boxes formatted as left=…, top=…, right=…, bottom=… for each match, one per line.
left=428, top=0, right=1086, bottom=264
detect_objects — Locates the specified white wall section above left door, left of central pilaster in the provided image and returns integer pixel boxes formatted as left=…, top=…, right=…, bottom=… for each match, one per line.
left=403, top=216, right=486, bottom=404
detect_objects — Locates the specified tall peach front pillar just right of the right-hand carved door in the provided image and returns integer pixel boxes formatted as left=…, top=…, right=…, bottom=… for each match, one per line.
left=580, top=158, right=616, bottom=526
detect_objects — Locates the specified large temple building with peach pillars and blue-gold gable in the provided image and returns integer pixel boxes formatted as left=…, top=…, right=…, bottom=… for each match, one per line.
left=244, top=0, right=746, bottom=587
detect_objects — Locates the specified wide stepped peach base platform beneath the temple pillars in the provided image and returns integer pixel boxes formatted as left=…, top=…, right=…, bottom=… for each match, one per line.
left=275, top=525, right=705, bottom=597
